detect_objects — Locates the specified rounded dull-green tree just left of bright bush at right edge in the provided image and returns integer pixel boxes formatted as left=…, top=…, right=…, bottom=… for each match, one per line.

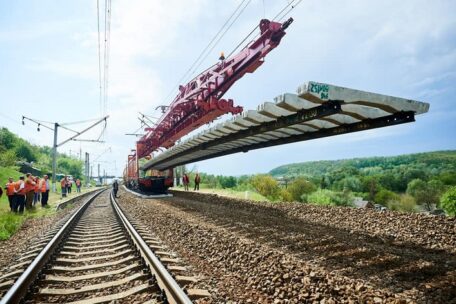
left=407, top=179, right=444, bottom=211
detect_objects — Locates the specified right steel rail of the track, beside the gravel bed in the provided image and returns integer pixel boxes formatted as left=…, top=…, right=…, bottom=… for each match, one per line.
left=110, top=192, right=192, bottom=304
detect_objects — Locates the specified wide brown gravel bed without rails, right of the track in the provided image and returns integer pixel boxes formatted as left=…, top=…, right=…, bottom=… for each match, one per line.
left=119, top=191, right=456, bottom=303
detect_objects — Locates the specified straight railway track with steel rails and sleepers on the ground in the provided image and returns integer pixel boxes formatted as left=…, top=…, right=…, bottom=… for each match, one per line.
left=0, top=191, right=201, bottom=304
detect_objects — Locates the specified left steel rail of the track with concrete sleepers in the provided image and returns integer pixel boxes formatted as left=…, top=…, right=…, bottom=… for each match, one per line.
left=0, top=189, right=106, bottom=304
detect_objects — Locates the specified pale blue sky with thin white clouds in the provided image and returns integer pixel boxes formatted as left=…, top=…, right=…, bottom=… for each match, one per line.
left=0, top=0, right=456, bottom=175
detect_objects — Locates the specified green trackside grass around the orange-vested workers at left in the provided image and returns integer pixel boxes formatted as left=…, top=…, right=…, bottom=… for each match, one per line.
left=0, top=167, right=100, bottom=241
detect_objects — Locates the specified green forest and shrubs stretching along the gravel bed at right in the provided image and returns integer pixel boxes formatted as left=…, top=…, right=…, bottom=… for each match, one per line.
left=186, top=151, right=456, bottom=216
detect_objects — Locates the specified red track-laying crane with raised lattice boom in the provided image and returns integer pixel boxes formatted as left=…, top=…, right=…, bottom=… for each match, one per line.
left=124, top=18, right=293, bottom=193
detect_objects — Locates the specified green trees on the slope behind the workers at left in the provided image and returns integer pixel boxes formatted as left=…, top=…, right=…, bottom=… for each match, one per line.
left=0, top=128, right=83, bottom=183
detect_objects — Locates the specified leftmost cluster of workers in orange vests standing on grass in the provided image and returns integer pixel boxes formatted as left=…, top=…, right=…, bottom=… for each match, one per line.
left=0, top=173, right=50, bottom=213
